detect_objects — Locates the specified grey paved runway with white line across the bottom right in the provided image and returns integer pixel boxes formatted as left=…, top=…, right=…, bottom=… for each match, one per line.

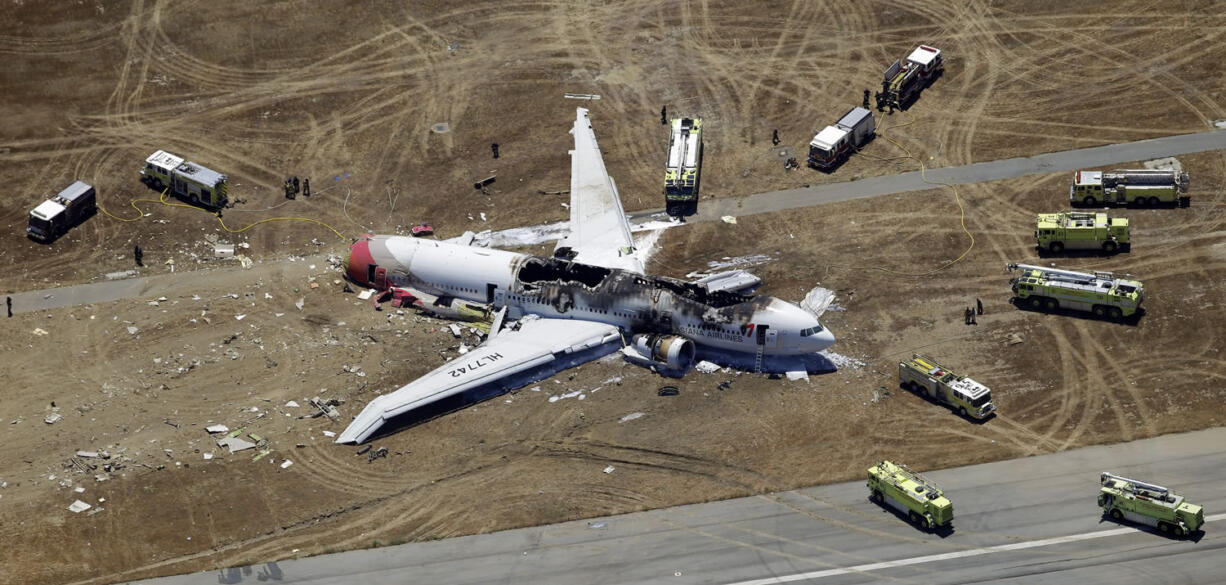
left=129, top=422, right=1226, bottom=585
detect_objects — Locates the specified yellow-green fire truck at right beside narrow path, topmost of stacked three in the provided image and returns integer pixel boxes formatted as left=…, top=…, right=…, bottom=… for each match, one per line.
left=1069, top=169, right=1189, bottom=207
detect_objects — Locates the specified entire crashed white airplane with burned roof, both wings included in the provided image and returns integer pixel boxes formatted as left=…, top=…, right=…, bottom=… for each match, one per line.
left=336, top=108, right=835, bottom=443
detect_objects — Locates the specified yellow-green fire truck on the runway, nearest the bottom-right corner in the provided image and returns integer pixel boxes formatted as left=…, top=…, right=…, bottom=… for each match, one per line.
left=1098, top=472, right=1205, bottom=537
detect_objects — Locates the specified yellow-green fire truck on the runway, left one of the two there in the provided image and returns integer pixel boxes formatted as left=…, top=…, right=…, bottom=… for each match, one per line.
left=868, top=461, right=954, bottom=532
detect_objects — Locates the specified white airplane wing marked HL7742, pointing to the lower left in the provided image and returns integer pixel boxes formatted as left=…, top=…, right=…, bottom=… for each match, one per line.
left=336, top=316, right=620, bottom=443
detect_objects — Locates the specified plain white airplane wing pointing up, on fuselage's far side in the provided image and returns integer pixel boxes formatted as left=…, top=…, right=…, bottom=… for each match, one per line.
left=557, top=108, right=642, bottom=275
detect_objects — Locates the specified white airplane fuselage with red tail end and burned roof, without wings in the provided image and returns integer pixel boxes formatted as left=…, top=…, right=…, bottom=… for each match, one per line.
left=348, top=235, right=834, bottom=354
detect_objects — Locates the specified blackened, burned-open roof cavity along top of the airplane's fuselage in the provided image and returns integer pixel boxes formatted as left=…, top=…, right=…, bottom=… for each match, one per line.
left=517, top=256, right=754, bottom=309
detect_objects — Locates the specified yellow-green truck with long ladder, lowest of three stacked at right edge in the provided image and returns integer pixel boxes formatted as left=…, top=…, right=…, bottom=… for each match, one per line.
left=1005, top=264, right=1145, bottom=320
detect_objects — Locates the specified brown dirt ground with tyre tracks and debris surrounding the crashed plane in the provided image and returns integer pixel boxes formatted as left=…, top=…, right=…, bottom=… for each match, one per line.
left=0, top=0, right=1226, bottom=584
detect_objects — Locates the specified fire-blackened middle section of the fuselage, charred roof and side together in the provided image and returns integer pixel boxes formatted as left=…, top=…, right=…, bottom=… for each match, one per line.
left=506, top=256, right=771, bottom=347
